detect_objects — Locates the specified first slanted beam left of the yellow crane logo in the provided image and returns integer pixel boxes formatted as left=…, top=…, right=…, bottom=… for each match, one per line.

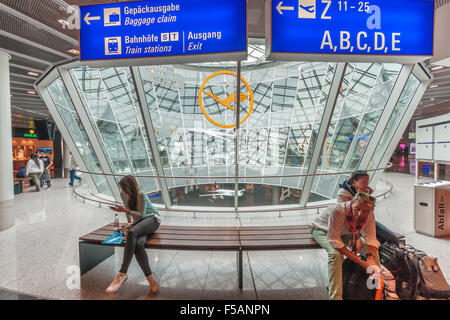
left=130, top=67, right=172, bottom=208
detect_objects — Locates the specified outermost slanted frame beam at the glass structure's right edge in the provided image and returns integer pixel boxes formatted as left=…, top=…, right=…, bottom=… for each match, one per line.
left=370, top=82, right=428, bottom=185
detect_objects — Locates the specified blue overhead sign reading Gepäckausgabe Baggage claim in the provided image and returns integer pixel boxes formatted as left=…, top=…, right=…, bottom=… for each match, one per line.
left=80, top=0, right=247, bottom=61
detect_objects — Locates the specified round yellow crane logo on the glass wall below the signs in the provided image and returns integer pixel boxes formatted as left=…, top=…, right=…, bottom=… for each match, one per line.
left=198, top=70, right=253, bottom=128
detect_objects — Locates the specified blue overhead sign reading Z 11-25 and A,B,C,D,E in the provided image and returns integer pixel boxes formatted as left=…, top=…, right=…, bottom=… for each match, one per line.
left=266, top=0, right=434, bottom=63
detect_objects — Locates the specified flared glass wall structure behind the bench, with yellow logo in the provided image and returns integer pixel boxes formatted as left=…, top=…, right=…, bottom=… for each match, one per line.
left=37, top=45, right=426, bottom=206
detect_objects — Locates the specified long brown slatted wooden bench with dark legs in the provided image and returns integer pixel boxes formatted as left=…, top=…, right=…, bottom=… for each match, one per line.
left=79, top=224, right=404, bottom=289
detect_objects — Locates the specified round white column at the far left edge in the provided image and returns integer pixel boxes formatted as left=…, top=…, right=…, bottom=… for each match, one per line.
left=0, top=51, right=15, bottom=231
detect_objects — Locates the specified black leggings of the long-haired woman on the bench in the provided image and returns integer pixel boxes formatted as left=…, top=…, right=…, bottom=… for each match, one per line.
left=120, top=216, right=159, bottom=277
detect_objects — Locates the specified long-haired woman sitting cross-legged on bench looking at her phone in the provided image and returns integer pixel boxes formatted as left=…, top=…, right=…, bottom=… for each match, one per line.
left=106, top=176, right=161, bottom=293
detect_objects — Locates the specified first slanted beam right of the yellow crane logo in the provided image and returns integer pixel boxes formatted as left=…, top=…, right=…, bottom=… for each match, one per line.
left=300, top=62, right=347, bottom=207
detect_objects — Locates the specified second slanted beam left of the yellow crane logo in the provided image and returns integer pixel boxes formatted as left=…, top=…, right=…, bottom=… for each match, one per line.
left=58, top=67, right=122, bottom=202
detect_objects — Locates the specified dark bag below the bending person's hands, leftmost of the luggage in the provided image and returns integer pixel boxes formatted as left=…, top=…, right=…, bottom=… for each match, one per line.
left=342, top=259, right=377, bottom=300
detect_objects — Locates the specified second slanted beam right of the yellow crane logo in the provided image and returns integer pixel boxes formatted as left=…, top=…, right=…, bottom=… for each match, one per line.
left=358, top=64, right=414, bottom=171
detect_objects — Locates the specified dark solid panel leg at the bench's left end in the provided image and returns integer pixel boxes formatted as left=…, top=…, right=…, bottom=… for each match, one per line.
left=78, top=241, right=114, bottom=275
